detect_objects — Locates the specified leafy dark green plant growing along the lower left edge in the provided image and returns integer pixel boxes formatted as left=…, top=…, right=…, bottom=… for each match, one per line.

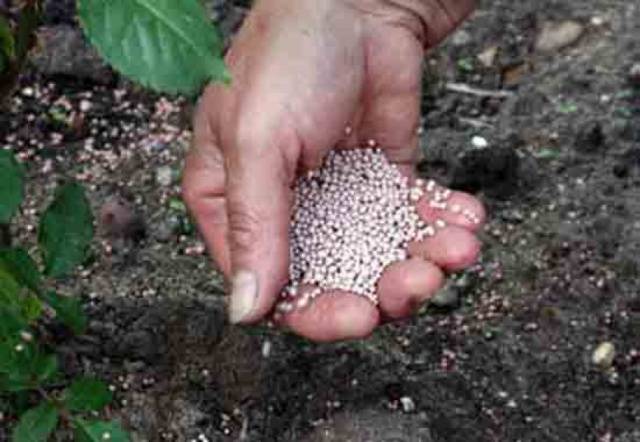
left=0, top=150, right=129, bottom=442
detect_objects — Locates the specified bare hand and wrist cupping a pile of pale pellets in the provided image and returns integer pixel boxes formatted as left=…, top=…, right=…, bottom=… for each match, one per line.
left=183, top=0, right=484, bottom=341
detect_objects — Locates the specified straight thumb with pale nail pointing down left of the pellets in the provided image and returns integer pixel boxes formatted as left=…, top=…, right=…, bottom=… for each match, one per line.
left=226, top=129, right=297, bottom=323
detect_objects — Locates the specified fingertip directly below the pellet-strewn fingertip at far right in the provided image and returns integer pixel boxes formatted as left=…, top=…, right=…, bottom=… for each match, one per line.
left=409, top=226, right=480, bottom=271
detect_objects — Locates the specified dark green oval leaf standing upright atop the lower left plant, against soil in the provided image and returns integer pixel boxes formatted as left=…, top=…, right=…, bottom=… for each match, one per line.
left=38, top=182, right=93, bottom=278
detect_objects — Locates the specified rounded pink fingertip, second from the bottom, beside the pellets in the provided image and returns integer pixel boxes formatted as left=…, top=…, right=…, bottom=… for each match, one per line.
left=378, top=258, right=444, bottom=319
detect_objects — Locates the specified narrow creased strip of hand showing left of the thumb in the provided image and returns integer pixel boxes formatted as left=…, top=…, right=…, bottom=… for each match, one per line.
left=182, top=106, right=231, bottom=276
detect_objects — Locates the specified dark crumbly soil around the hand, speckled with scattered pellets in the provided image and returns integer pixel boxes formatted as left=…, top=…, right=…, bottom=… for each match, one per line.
left=0, top=0, right=640, bottom=442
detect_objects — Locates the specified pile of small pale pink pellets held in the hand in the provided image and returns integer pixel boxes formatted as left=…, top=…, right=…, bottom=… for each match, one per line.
left=276, top=147, right=478, bottom=315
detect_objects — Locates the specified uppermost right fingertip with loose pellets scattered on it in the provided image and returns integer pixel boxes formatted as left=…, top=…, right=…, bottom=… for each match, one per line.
left=416, top=184, right=486, bottom=232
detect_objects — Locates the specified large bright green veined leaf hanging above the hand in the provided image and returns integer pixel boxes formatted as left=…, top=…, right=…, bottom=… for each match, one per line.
left=78, top=0, right=229, bottom=94
